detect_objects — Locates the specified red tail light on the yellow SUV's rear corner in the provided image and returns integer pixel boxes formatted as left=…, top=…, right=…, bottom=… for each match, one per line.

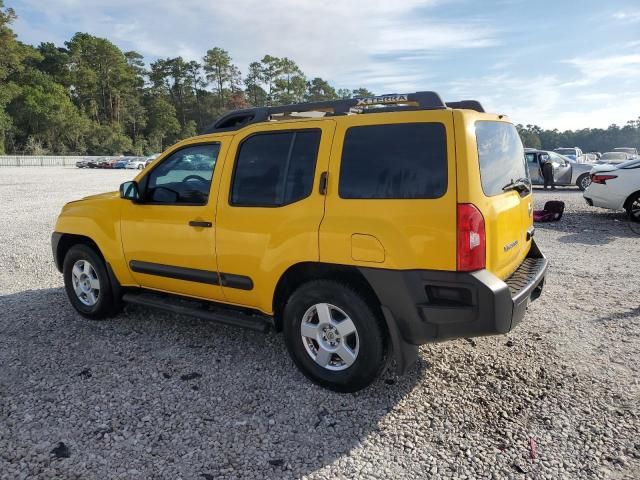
left=457, top=203, right=487, bottom=272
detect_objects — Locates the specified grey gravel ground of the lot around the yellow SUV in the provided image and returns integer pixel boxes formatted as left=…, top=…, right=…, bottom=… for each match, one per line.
left=0, top=168, right=640, bottom=480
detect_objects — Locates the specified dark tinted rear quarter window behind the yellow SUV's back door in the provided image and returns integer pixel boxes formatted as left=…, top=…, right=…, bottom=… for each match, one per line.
left=339, top=123, right=447, bottom=198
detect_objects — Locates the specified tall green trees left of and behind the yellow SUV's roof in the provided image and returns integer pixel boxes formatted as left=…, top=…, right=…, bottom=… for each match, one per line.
left=0, top=0, right=373, bottom=155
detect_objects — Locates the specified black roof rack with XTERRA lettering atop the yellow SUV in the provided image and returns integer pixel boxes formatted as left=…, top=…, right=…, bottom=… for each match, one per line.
left=204, top=92, right=484, bottom=134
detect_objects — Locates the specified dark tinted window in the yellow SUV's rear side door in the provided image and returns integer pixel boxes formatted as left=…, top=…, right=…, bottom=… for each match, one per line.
left=230, top=130, right=321, bottom=207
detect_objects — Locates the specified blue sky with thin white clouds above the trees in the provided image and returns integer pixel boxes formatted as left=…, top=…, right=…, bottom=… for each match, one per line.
left=5, top=0, right=640, bottom=129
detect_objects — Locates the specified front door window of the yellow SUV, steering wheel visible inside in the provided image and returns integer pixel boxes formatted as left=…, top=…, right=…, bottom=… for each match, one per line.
left=143, top=144, right=220, bottom=205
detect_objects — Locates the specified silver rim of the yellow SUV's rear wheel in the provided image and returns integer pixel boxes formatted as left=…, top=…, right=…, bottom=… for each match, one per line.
left=300, top=303, right=360, bottom=371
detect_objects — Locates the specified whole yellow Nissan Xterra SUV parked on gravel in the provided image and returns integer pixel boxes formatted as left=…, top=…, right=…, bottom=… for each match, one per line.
left=52, top=92, right=547, bottom=391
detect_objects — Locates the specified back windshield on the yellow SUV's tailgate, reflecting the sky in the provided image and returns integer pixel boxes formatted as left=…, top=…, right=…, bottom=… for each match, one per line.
left=476, top=120, right=529, bottom=197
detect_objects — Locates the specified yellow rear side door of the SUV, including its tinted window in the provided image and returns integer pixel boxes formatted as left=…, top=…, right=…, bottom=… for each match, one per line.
left=216, top=119, right=335, bottom=313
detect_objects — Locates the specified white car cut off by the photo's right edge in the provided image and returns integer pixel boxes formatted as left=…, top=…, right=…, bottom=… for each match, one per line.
left=584, top=160, right=640, bottom=222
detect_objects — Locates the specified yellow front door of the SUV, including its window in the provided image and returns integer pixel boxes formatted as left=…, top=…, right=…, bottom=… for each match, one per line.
left=120, top=137, right=226, bottom=300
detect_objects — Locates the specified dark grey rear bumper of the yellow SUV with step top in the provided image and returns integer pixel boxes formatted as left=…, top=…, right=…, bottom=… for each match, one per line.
left=361, top=241, right=548, bottom=345
